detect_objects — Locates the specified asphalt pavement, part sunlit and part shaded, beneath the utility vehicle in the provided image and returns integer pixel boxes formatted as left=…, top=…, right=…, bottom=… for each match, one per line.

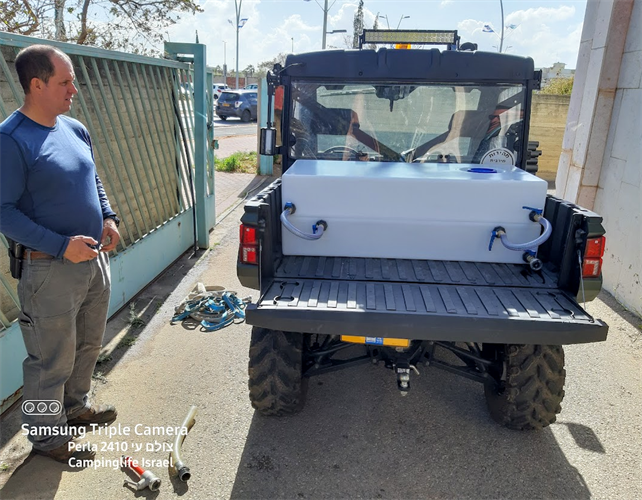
left=0, top=207, right=642, bottom=500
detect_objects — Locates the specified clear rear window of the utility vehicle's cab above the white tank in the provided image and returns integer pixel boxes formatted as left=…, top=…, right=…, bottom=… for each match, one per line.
left=289, top=82, right=525, bottom=165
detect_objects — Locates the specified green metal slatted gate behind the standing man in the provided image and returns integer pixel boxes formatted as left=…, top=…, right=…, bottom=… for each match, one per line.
left=0, top=33, right=215, bottom=413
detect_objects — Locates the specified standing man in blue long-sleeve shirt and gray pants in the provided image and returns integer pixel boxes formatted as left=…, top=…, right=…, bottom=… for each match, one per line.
left=0, top=45, right=120, bottom=462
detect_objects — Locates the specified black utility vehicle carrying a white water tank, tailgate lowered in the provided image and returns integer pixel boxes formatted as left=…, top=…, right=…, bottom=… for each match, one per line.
left=237, top=30, right=608, bottom=430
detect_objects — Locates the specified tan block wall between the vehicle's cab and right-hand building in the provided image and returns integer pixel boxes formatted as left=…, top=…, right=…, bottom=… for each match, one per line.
left=528, top=94, right=571, bottom=181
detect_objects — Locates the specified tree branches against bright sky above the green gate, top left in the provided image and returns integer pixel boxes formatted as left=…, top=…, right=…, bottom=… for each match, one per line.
left=0, top=0, right=203, bottom=54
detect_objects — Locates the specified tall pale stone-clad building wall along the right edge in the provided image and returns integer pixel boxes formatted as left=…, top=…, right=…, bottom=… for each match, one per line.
left=556, top=0, right=642, bottom=315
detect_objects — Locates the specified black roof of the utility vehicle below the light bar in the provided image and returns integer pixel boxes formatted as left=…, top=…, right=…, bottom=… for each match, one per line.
left=281, top=48, right=540, bottom=83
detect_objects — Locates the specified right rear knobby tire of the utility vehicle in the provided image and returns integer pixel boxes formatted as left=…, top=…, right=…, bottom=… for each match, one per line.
left=484, top=344, right=566, bottom=430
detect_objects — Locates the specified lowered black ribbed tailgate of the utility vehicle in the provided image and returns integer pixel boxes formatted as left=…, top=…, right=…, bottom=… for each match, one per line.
left=246, top=279, right=608, bottom=345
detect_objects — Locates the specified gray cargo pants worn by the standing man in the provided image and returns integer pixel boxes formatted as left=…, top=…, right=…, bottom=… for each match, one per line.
left=18, top=253, right=110, bottom=451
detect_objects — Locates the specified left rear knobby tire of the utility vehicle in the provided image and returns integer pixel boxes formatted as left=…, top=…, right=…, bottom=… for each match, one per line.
left=248, top=326, right=307, bottom=416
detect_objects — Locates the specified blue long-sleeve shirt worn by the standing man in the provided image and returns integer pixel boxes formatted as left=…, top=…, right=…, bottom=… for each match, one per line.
left=0, top=111, right=115, bottom=257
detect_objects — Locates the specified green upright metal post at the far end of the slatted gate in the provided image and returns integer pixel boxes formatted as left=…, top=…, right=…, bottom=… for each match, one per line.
left=165, top=42, right=211, bottom=248
